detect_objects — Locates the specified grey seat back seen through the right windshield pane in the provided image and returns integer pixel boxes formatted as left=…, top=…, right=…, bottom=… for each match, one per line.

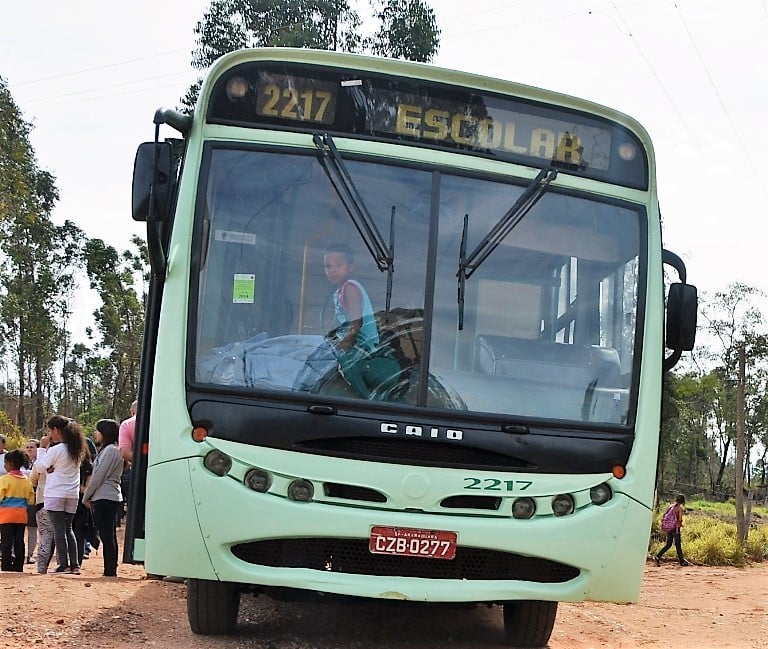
left=475, top=335, right=621, bottom=388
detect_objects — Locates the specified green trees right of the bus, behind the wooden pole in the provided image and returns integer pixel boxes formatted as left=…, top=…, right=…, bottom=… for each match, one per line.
left=658, top=282, right=768, bottom=498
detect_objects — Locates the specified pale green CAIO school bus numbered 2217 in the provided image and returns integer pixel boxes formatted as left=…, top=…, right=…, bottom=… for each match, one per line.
left=124, top=48, right=697, bottom=646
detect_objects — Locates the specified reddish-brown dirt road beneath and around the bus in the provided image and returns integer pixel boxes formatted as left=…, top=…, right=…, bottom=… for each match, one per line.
left=0, top=556, right=768, bottom=649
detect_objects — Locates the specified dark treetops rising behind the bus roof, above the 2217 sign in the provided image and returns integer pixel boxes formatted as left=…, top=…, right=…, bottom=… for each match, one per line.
left=181, top=0, right=440, bottom=112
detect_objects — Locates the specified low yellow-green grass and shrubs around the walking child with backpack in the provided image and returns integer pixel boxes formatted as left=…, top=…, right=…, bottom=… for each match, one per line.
left=649, top=500, right=768, bottom=566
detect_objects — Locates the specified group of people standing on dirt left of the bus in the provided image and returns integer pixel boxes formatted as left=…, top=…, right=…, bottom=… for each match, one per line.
left=0, top=402, right=136, bottom=577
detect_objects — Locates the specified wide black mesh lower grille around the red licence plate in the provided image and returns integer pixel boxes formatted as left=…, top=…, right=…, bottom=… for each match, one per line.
left=232, top=538, right=579, bottom=584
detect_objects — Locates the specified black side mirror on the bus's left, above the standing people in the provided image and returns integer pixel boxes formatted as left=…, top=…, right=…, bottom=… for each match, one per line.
left=132, top=142, right=173, bottom=221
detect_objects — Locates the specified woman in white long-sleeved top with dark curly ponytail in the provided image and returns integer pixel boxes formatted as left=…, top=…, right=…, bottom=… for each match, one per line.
left=37, top=415, right=86, bottom=575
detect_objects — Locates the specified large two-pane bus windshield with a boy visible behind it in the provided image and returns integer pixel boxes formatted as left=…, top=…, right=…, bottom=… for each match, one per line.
left=194, top=144, right=646, bottom=425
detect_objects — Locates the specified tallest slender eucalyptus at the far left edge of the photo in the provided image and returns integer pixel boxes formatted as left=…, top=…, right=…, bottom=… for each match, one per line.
left=0, top=80, right=83, bottom=432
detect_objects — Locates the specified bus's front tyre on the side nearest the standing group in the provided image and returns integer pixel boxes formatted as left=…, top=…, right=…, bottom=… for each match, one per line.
left=187, top=579, right=240, bottom=635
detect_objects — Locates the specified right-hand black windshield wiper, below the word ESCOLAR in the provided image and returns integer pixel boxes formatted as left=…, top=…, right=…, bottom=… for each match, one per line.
left=456, top=169, right=557, bottom=331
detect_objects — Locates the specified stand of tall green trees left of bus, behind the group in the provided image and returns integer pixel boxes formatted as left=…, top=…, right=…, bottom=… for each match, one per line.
left=0, top=78, right=147, bottom=430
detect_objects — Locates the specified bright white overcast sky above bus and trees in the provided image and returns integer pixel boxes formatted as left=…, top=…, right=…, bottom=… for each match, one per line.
left=0, top=0, right=768, bottom=329
